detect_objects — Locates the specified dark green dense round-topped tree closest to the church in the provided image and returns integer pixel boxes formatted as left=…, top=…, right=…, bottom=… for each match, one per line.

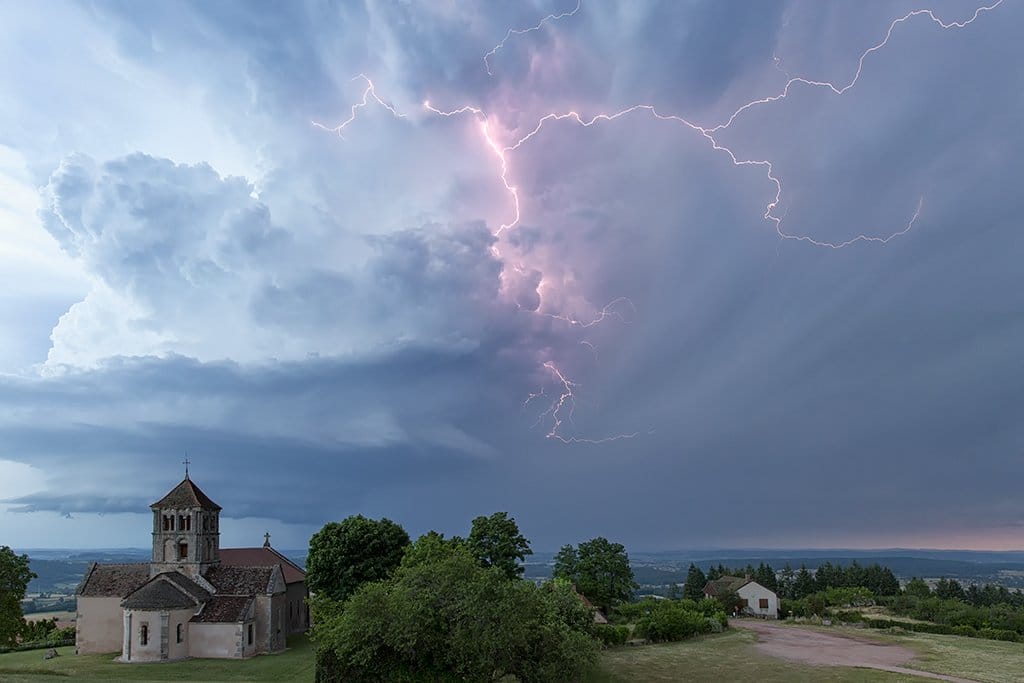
left=306, top=515, right=409, bottom=601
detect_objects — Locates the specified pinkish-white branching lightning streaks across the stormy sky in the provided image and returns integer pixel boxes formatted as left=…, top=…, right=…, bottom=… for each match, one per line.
left=313, top=0, right=1004, bottom=443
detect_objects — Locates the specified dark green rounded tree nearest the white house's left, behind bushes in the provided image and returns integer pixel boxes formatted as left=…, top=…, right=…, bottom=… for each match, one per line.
left=553, top=537, right=638, bottom=610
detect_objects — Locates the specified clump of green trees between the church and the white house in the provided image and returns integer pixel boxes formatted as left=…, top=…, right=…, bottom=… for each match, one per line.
left=306, top=512, right=636, bottom=682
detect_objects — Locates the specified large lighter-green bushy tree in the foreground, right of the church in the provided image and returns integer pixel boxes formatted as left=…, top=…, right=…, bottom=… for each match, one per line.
left=316, top=545, right=597, bottom=683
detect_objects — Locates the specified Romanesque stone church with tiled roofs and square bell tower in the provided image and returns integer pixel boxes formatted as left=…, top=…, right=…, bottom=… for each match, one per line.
left=75, top=473, right=309, bottom=661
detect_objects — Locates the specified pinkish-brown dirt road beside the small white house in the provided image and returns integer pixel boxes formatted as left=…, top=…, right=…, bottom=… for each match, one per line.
left=729, top=620, right=973, bottom=683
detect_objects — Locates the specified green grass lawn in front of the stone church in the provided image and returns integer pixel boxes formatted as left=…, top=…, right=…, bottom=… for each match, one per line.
left=0, top=636, right=314, bottom=683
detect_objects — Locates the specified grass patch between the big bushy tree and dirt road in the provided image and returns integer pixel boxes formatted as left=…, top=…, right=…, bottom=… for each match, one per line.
left=589, top=629, right=925, bottom=683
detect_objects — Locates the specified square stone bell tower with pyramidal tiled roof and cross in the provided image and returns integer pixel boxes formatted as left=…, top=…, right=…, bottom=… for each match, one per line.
left=150, top=461, right=221, bottom=577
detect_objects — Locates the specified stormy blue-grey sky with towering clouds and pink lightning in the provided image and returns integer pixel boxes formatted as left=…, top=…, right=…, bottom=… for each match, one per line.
left=0, top=0, right=1024, bottom=551
